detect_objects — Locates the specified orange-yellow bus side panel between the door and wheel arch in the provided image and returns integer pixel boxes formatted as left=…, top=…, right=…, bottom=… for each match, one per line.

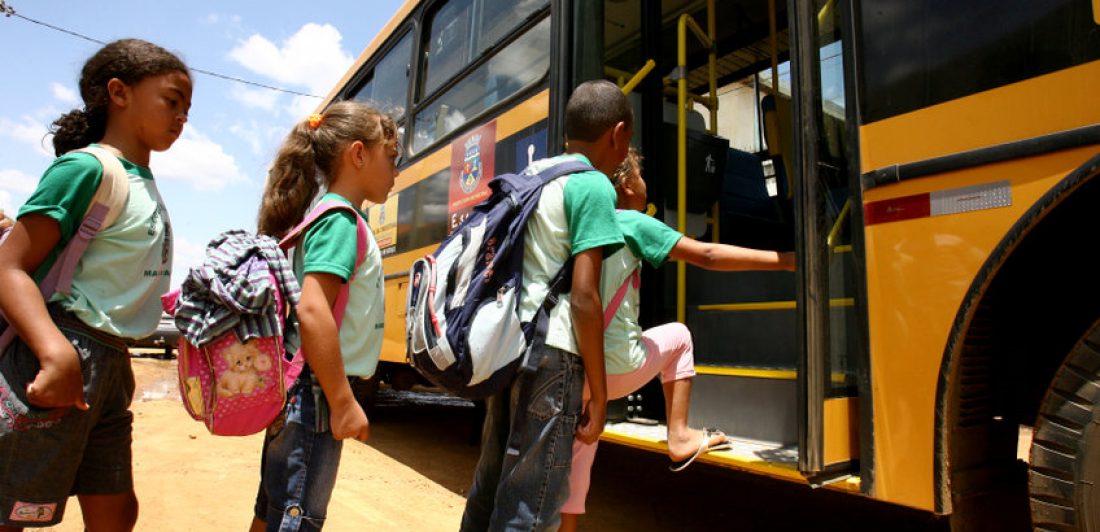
left=860, top=63, right=1100, bottom=510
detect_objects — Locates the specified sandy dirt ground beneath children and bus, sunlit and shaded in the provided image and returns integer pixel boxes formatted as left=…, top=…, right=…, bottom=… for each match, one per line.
left=34, top=357, right=947, bottom=532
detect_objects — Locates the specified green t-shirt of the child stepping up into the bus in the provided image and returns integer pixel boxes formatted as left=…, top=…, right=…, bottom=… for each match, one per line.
left=600, top=211, right=683, bottom=375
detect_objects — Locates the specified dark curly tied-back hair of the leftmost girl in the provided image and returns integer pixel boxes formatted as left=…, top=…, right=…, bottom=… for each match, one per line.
left=50, top=38, right=191, bottom=156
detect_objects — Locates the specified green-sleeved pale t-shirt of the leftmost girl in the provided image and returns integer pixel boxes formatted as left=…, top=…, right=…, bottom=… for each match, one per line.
left=19, top=146, right=172, bottom=337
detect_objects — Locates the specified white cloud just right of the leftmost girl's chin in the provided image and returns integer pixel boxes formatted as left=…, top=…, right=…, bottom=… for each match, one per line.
left=150, top=126, right=248, bottom=191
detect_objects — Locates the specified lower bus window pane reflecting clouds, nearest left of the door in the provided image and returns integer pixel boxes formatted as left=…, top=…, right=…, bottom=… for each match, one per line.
left=411, top=18, right=550, bottom=153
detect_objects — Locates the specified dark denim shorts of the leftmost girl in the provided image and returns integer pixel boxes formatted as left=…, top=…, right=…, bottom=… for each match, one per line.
left=0, top=304, right=134, bottom=527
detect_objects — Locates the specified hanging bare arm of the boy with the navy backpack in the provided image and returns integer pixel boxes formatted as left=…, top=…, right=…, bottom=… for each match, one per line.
left=570, top=247, right=607, bottom=443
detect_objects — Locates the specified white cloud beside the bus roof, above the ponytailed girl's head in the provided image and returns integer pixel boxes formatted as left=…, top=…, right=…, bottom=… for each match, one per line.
left=229, top=22, right=353, bottom=98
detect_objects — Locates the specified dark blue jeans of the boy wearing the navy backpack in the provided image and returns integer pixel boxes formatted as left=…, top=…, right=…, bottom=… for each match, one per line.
left=460, top=347, right=584, bottom=532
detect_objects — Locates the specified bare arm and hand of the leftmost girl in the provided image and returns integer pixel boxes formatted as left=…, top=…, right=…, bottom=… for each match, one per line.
left=0, top=214, right=88, bottom=410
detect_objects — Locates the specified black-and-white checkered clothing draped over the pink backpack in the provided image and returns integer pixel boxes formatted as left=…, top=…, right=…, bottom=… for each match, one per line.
left=175, top=230, right=299, bottom=347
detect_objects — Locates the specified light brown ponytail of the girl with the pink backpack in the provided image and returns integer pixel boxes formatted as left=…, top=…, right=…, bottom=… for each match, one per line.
left=257, top=122, right=321, bottom=239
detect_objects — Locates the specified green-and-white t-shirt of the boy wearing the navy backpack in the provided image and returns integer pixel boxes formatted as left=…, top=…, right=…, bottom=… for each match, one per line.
left=519, top=154, right=623, bottom=353
